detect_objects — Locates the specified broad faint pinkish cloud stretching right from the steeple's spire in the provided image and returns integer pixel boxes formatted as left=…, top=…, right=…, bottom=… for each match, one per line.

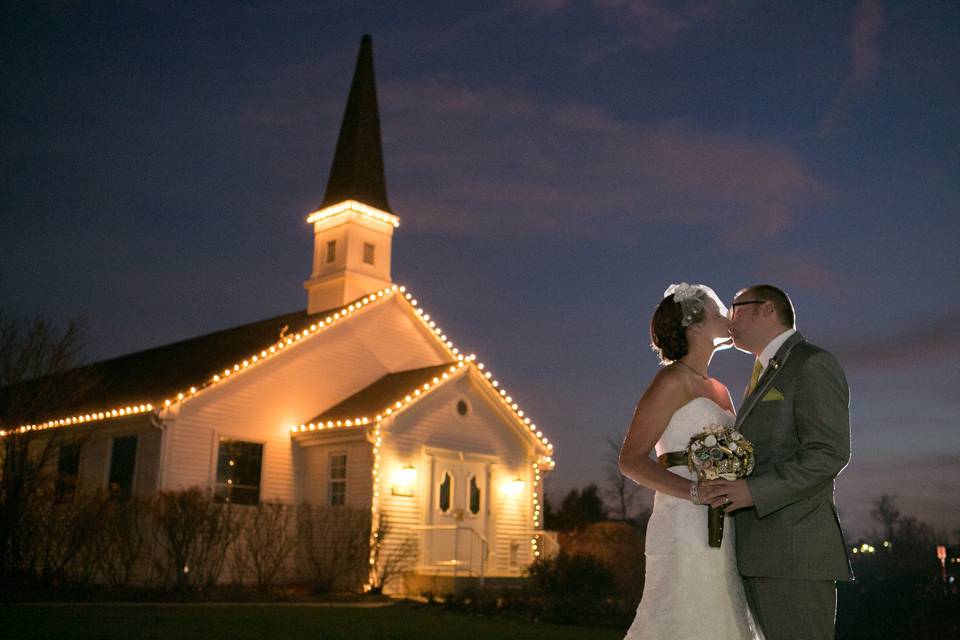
left=372, top=78, right=831, bottom=243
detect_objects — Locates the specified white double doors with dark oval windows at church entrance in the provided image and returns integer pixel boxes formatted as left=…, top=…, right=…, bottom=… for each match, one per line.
left=424, top=456, right=490, bottom=575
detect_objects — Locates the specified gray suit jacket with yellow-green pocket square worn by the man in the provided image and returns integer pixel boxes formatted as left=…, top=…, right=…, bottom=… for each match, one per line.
left=735, top=333, right=853, bottom=580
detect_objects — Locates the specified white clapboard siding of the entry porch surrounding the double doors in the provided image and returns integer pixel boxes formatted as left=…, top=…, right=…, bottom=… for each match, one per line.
left=380, top=370, right=533, bottom=575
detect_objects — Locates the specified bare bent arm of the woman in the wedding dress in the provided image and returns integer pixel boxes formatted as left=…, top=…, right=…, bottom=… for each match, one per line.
left=620, top=369, right=690, bottom=500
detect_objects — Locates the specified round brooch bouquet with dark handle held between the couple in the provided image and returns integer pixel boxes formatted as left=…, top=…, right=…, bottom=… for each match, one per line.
left=687, top=424, right=754, bottom=547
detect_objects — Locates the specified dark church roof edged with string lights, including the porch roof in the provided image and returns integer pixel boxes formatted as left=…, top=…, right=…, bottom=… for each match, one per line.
left=0, top=285, right=553, bottom=460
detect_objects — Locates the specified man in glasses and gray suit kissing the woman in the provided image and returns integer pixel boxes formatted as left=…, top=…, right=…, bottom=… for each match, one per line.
left=700, top=285, right=853, bottom=640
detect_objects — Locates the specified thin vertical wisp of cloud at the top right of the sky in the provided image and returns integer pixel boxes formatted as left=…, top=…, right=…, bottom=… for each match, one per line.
left=819, top=0, right=884, bottom=135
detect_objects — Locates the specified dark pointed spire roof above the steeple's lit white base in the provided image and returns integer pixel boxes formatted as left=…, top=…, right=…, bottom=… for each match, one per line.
left=320, top=35, right=393, bottom=213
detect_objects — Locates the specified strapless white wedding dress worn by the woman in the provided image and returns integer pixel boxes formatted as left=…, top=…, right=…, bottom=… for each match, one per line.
left=625, top=397, right=763, bottom=640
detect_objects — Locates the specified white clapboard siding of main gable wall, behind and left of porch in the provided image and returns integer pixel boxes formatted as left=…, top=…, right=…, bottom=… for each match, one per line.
left=162, top=297, right=448, bottom=503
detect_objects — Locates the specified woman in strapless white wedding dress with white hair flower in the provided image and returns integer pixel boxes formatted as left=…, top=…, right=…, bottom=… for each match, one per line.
left=620, top=283, right=763, bottom=640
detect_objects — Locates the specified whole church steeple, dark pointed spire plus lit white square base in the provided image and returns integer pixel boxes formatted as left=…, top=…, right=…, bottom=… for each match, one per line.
left=303, top=35, right=400, bottom=313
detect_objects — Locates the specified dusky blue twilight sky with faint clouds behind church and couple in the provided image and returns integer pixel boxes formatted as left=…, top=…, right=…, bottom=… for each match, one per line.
left=0, top=0, right=960, bottom=534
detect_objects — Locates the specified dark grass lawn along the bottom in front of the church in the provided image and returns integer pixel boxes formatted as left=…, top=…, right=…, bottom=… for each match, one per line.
left=0, top=604, right=625, bottom=640
